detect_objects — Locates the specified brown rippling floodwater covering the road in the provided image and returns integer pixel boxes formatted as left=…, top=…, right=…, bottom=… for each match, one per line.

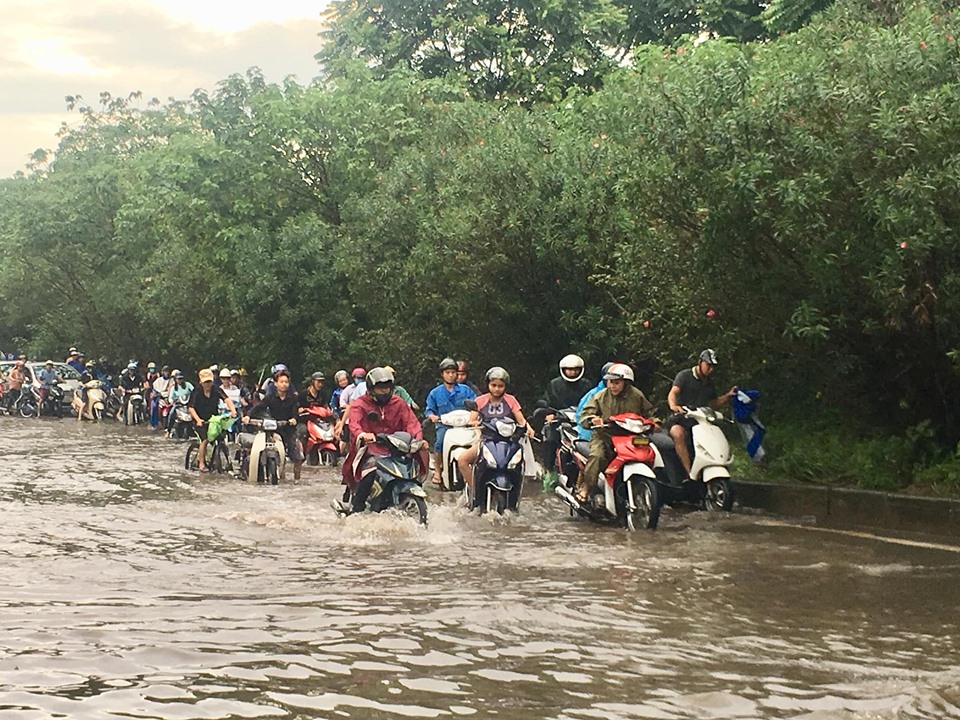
left=0, top=418, right=960, bottom=720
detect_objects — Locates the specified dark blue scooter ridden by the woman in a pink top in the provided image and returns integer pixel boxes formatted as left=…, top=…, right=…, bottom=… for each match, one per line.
left=464, top=418, right=527, bottom=515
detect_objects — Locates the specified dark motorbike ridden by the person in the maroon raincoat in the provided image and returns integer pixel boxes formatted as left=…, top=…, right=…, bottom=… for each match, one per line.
left=344, top=430, right=427, bottom=525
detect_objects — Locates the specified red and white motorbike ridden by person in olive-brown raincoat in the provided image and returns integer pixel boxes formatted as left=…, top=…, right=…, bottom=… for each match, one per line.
left=554, top=413, right=664, bottom=530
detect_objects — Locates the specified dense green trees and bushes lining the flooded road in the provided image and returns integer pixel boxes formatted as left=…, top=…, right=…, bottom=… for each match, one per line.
left=0, top=0, right=960, bottom=492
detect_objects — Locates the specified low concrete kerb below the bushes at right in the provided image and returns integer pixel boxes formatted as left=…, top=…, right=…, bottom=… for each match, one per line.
left=734, top=480, right=960, bottom=537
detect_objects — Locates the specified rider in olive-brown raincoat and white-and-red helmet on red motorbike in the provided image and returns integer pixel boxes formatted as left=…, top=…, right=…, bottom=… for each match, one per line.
left=577, top=363, right=653, bottom=502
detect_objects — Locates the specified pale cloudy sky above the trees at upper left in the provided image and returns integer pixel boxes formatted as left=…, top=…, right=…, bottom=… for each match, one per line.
left=0, top=0, right=326, bottom=177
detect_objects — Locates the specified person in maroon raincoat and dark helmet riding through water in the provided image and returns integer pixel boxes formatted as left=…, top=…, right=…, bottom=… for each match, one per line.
left=331, top=367, right=427, bottom=515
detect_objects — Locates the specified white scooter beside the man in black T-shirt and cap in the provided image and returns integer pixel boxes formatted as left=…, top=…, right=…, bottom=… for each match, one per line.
left=657, top=407, right=733, bottom=512
